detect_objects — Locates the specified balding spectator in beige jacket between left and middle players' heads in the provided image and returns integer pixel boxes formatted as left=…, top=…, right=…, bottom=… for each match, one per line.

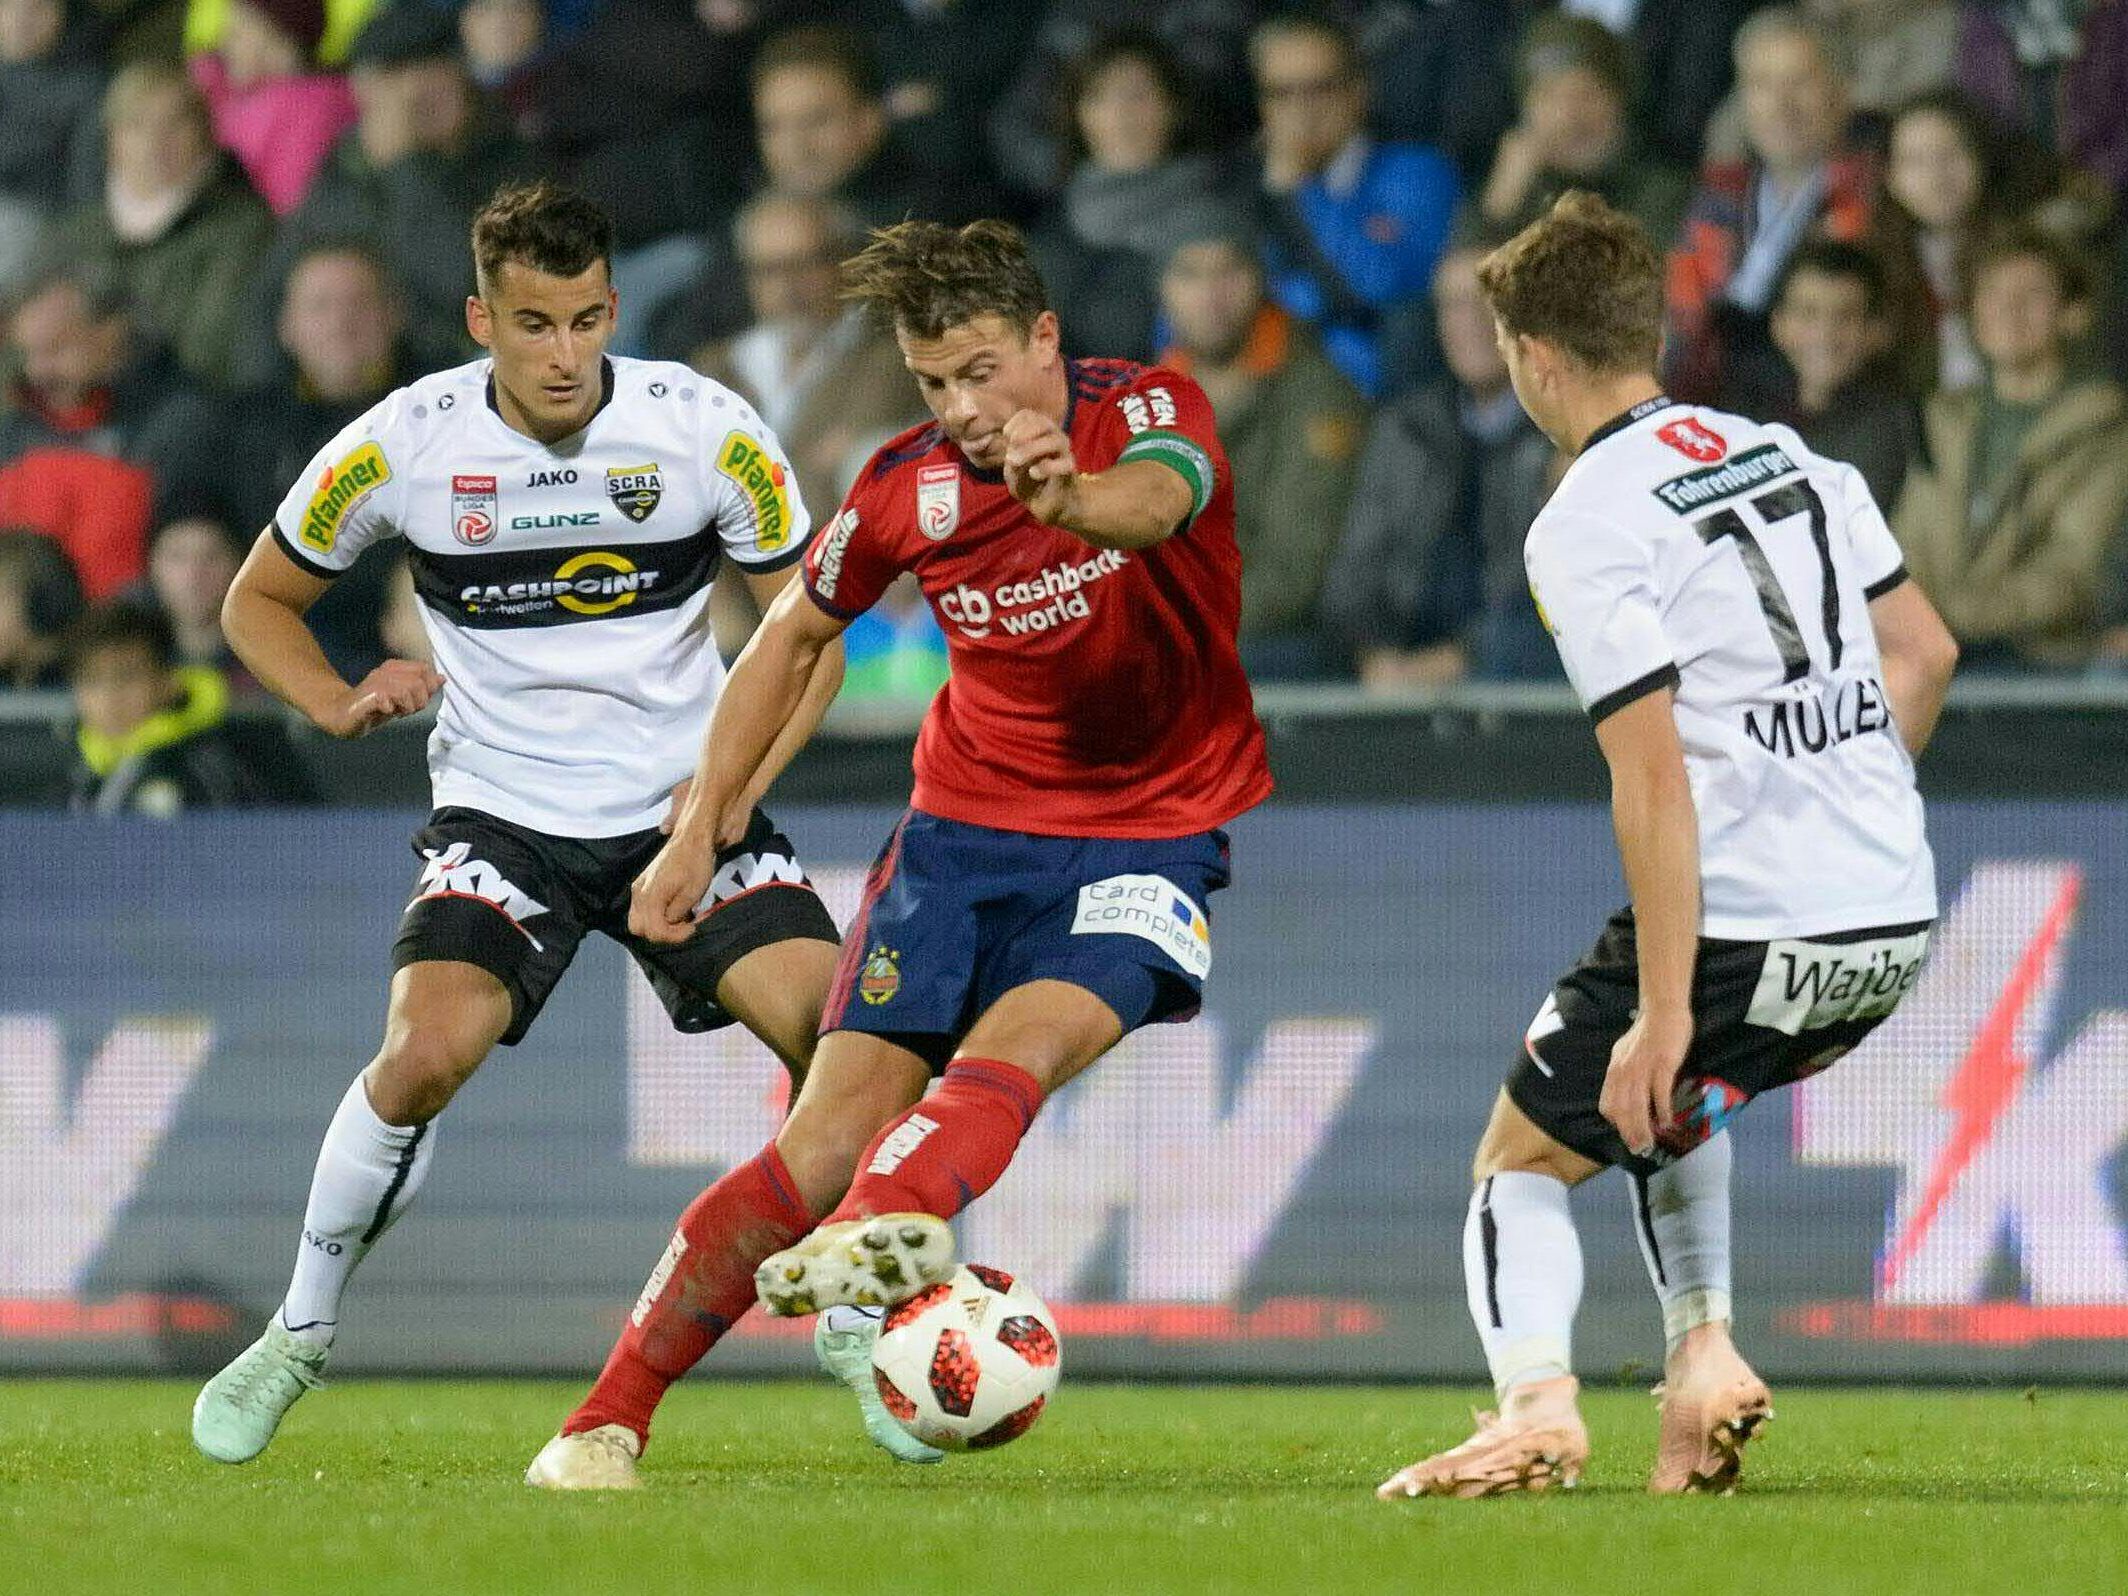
left=694, top=194, right=926, bottom=519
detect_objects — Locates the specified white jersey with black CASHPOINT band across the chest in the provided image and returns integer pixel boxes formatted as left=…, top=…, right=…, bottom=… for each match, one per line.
left=275, top=358, right=809, bottom=836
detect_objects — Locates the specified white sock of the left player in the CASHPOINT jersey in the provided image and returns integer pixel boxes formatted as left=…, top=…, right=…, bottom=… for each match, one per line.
left=279, top=1075, right=436, bottom=1347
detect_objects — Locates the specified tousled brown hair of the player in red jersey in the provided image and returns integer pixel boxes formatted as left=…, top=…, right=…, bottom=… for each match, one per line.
left=843, top=221, right=1049, bottom=338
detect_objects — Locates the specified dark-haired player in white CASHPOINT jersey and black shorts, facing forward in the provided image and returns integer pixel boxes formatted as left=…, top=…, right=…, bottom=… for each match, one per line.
left=192, top=185, right=876, bottom=1462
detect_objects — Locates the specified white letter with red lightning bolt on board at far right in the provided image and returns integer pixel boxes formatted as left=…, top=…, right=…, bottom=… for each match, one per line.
left=1783, top=862, right=2128, bottom=1345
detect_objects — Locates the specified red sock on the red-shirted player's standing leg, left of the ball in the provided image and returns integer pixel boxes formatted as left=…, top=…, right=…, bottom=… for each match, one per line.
left=562, top=1143, right=813, bottom=1443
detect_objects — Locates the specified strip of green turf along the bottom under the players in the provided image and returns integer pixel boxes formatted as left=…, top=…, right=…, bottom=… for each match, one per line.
left=0, top=1381, right=2128, bottom=1596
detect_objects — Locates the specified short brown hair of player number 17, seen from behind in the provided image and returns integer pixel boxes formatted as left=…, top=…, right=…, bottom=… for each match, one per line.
left=1477, top=189, right=1662, bottom=377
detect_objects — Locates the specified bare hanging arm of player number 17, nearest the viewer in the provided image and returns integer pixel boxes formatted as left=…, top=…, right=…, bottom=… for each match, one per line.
left=1596, top=689, right=1700, bottom=1151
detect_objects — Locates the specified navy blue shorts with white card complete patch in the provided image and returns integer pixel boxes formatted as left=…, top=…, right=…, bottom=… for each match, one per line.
left=819, top=809, right=1230, bottom=1068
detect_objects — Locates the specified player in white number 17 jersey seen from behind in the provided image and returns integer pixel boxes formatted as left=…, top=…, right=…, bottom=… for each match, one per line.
left=1379, top=194, right=1958, bottom=1500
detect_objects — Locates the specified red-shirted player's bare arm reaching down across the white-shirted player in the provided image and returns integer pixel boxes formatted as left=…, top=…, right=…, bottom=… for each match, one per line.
left=628, top=581, right=845, bottom=943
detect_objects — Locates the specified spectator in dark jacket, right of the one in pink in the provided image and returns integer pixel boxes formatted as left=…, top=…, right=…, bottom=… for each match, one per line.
left=236, top=4, right=530, bottom=387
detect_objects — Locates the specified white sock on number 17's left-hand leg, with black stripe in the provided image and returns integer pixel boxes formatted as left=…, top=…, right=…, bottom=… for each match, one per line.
left=1464, top=1170, right=1581, bottom=1398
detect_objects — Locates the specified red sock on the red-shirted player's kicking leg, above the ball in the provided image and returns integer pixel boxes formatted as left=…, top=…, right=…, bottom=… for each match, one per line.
left=828, top=1058, right=1043, bottom=1224
